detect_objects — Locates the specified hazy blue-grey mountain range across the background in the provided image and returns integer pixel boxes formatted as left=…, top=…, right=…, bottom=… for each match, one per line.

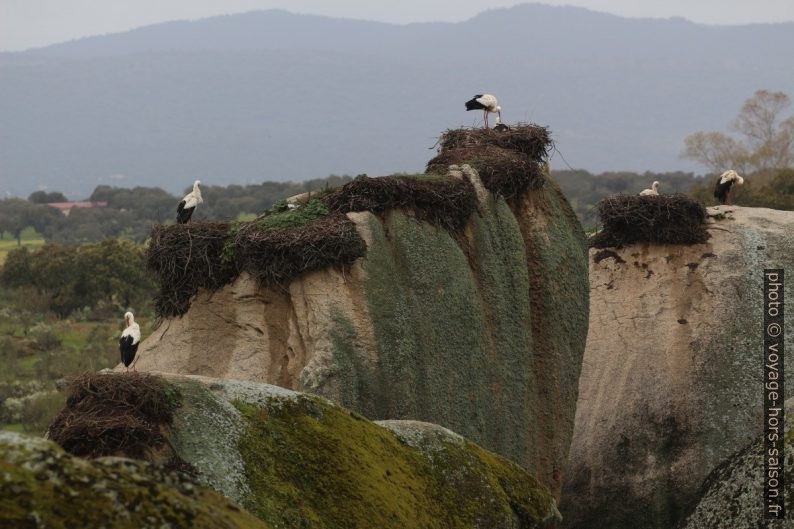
left=0, top=4, right=794, bottom=196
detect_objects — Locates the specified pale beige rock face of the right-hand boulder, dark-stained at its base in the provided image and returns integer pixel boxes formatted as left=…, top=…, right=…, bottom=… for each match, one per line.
left=561, top=207, right=794, bottom=529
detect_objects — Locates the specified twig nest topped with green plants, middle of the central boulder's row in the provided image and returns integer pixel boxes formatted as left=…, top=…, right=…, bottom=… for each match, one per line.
left=232, top=214, right=367, bottom=285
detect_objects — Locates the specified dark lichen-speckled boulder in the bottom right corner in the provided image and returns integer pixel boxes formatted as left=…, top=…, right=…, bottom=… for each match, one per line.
left=681, top=399, right=794, bottom=529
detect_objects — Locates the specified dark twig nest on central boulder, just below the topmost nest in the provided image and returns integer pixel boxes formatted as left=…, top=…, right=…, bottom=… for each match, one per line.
left=322, top=176, right=477, bottom=231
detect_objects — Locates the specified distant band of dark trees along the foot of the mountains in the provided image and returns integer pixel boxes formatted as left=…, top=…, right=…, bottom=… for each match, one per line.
left=0, top=169, right=794, bottom=241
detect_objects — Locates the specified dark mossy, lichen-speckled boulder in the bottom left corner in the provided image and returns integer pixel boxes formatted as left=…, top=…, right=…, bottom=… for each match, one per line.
left=0, top=432, right=270, bottom=529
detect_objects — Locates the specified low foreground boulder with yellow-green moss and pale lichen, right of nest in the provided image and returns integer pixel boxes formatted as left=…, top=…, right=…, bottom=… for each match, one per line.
left=155, top=376, right=560, bottom=529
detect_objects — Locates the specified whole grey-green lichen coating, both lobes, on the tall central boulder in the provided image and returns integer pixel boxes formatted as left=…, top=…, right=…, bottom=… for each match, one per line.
left=358, top=204, right=537, bottom=469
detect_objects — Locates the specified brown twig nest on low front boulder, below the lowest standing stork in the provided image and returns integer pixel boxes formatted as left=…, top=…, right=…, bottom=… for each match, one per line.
left=48, top=373, right=181, bottom=459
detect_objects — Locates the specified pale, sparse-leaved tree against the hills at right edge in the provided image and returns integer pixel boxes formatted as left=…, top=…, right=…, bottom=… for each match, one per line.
left=681, top=90, right=794, bottom=175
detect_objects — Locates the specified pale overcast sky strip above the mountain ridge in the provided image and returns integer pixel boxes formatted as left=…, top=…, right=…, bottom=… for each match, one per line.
left=0, top=0, right=794, bottom=51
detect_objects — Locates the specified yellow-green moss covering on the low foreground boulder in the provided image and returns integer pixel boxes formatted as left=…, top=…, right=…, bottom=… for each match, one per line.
left=237, top=397, right=555, bottom=529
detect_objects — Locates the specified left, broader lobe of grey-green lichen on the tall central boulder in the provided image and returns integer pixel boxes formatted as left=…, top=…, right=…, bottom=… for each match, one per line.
left=364, top=211, right=489, bottom=428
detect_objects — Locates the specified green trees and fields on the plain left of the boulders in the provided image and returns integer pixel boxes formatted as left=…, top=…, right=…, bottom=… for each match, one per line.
left=0, top=176, right=350, bottom=434
